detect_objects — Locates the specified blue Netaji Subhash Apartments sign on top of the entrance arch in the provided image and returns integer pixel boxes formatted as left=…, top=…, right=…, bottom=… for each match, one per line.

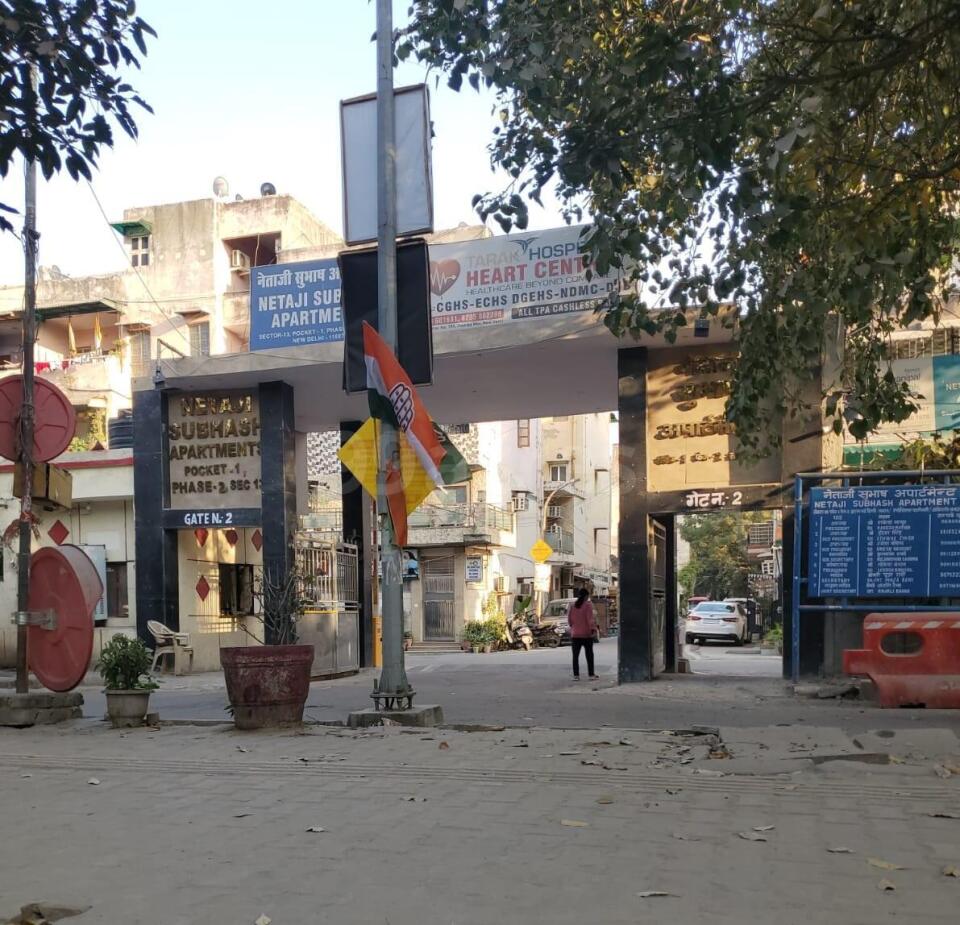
left=250, top=260, right=343, bottom=350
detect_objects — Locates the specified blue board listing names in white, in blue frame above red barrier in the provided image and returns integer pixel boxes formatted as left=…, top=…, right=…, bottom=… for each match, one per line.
left=809, top=485, right=960, bottom=597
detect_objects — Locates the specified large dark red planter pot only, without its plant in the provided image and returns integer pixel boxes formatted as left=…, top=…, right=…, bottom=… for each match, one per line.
left=220, top=646, right=314, bottom=729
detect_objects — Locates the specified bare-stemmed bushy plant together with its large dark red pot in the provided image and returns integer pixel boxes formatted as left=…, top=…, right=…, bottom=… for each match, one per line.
left=220, top=569, right=314, bottom=729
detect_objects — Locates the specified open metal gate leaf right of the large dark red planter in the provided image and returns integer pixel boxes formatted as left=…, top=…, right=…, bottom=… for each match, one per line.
left=296, top=531, right=360, bottom=677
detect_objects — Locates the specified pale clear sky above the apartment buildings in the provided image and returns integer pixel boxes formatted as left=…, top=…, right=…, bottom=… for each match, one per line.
left=0, top=0, right=562, bottom=284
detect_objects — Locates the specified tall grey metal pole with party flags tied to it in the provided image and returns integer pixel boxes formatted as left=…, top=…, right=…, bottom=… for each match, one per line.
left=373, top=0, right=413, bottom=707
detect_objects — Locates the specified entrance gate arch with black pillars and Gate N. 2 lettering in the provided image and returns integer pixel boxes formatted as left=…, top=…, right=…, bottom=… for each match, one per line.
left=134, top=278, right=840, bottom=682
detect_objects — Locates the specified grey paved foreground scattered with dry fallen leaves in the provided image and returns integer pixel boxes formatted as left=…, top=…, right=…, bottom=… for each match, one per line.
left=0, top=721, right=960, bottom=925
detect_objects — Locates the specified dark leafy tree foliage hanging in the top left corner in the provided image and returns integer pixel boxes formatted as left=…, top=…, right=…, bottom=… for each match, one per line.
left=0, top=0, right=156, bottom=231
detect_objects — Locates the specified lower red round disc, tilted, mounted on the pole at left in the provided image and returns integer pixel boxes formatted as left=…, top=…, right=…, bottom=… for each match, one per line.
left=27, top=545, right=103, bottom=692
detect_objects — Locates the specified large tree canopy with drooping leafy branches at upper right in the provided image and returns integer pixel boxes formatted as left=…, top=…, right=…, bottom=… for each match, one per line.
left=397, top=0, right=960, bottom=453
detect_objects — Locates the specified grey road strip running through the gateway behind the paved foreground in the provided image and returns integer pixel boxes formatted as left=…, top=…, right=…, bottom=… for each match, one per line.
left=73, top=639, right=956, bottom=732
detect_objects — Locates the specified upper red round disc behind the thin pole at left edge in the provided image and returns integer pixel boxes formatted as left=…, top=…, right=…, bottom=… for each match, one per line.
left=0, top=375, right=77, bottom=463
